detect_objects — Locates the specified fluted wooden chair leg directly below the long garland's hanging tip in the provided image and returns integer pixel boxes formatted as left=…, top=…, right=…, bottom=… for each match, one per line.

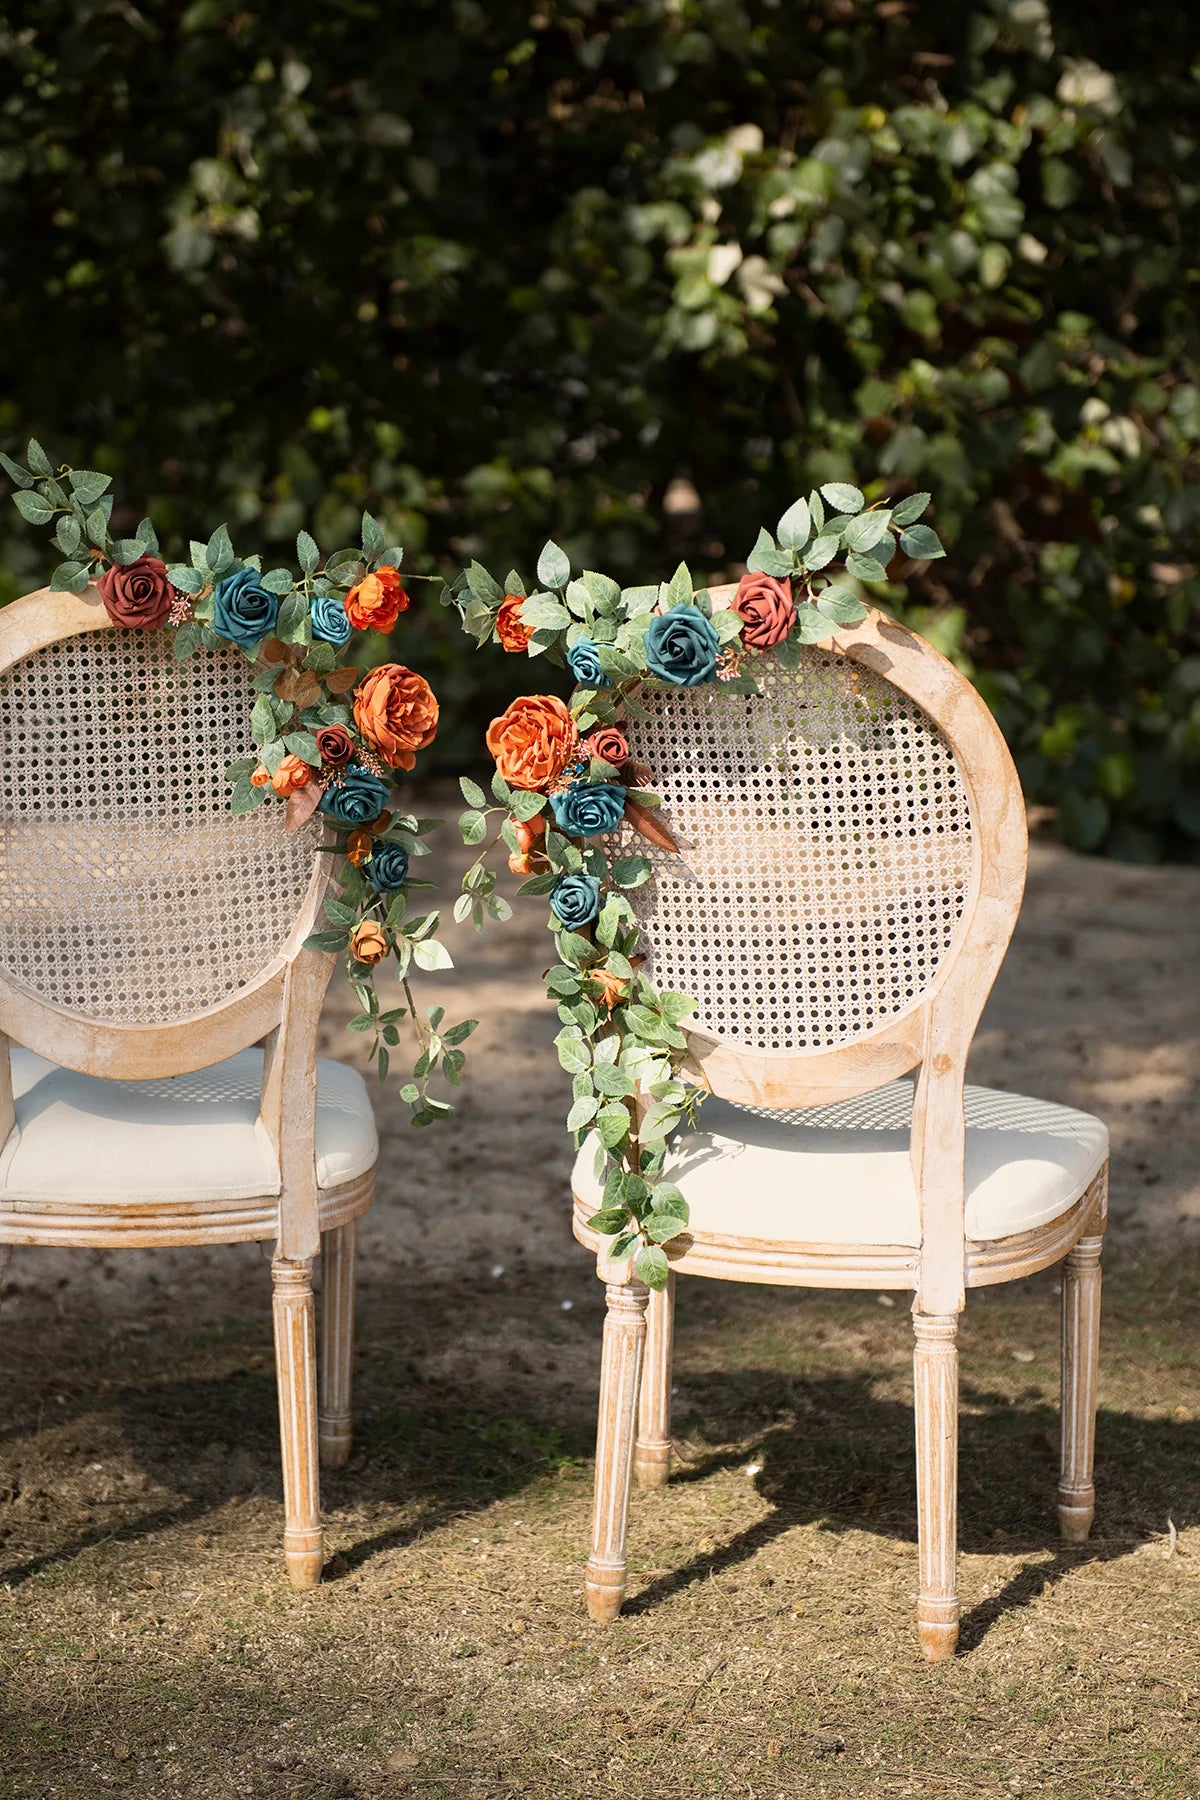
left=583, top=1282, right=649, bottom=1625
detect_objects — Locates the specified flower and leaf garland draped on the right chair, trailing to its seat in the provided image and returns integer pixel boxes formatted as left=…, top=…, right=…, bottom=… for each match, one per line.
left=443, top=482, right=945, bottom=1287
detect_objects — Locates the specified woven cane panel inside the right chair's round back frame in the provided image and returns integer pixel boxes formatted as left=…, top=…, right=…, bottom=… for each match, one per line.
left=613, top=648, right=972, bottom=1049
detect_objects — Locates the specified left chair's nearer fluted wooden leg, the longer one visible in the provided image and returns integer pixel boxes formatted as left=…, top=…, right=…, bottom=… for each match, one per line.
left=272, top=1256, right=324, bottom=1588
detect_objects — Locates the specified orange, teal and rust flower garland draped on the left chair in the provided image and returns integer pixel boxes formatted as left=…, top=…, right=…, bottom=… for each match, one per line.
left=0, top=439, right=477, bottom=1125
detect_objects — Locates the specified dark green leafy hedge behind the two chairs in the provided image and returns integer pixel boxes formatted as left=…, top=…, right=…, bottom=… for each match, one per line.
left=0, top=0, right=1200, bottom=859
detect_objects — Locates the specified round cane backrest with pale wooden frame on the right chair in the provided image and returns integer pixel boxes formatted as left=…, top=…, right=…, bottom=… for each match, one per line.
left=624, top=597, right=1025, bottom=1107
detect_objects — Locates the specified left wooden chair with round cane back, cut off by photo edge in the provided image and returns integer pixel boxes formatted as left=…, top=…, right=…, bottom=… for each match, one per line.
left=0, top=589, right=378, bottom=1588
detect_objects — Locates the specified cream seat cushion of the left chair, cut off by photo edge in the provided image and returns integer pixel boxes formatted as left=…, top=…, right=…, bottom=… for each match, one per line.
left=0, top=1046, right=380, bottom=1204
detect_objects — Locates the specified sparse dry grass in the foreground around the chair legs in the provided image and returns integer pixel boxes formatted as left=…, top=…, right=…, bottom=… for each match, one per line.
left=0, top=1251, right=1200, bottom=1800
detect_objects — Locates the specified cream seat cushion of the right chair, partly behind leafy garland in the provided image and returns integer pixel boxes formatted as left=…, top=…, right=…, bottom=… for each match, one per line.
left=574, top=1080, right=1108, bottom=1246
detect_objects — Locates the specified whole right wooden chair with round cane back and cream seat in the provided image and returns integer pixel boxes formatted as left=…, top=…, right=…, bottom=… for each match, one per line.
left=574, top=612, right=1108, bottom=1660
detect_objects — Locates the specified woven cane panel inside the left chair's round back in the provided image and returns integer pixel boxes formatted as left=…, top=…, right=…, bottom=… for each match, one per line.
left=0, top=630, right=317, bottom=1024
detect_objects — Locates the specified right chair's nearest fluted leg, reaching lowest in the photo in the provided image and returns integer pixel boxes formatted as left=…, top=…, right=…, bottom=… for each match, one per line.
left=912, top=1312, right=959, bottom=1663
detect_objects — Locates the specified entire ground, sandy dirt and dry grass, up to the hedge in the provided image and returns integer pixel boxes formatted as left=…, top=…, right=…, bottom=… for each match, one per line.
left=0, top=794, right=1200, bottom=1800
